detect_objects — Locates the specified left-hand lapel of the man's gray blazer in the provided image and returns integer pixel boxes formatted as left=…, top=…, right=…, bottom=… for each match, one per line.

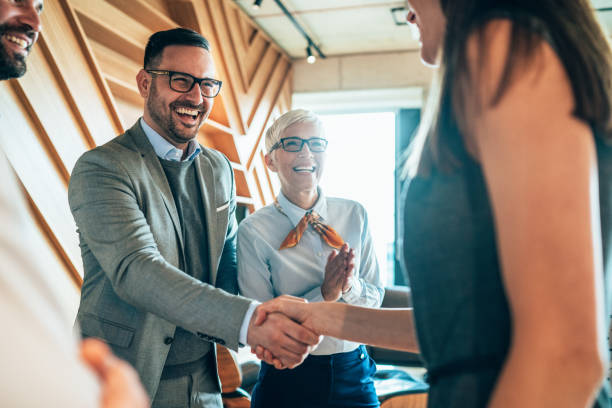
left=127, top=120, right=185, bottom=248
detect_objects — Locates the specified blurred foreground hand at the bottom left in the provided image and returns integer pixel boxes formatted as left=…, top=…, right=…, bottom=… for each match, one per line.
left=81, top=338, right=149, bottom=408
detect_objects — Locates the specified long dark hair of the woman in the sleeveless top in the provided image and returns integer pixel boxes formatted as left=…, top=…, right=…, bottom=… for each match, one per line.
left=406, top=0, right=612, bottom=172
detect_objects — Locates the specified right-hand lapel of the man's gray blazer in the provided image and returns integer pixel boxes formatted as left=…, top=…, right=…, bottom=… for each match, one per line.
left=195, top=152, right=217, bottom=283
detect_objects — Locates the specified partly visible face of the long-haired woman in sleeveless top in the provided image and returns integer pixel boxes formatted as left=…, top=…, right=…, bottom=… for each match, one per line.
left=406, top=0, right=446, bottom=66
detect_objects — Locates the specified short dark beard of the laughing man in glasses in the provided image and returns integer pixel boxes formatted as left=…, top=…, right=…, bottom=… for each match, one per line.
left=147, top=81, right=208, bottom=143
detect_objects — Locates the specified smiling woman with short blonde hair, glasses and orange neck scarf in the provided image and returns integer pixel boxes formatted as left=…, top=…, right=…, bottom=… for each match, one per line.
left=238, top=109, right=384, bottom=408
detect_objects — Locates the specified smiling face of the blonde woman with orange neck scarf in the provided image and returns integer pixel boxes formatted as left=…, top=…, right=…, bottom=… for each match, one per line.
left=266, top=122, right=326, bottom=202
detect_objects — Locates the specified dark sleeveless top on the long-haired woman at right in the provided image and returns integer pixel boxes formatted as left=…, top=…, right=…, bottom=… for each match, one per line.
left=402, top=15, right=612, bottom=408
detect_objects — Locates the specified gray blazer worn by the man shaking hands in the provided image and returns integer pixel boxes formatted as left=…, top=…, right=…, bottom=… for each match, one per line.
left=68, top=122, right=250, bottom=398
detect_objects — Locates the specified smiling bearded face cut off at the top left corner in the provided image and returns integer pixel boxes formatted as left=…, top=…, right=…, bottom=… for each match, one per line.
left=0, top=0, right=43, bottom=80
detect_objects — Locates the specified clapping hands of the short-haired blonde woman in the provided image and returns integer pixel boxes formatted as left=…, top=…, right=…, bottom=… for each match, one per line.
left=321, top=243, right=355, bottom=302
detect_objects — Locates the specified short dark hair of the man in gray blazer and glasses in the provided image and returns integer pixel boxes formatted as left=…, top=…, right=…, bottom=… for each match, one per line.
left=143, top=27, right=210, bottom=69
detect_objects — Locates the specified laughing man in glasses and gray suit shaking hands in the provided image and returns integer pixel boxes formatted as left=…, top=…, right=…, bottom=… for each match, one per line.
left=69, top=28, right=319, bottom=407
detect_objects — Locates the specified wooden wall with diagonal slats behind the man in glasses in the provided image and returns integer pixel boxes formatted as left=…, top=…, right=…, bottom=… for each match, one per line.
left=0, top=0, right=291, bottom=319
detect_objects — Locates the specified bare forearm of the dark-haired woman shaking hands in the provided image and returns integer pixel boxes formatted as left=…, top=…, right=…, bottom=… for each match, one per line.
left=308, top=302, right=419, bottom=353
